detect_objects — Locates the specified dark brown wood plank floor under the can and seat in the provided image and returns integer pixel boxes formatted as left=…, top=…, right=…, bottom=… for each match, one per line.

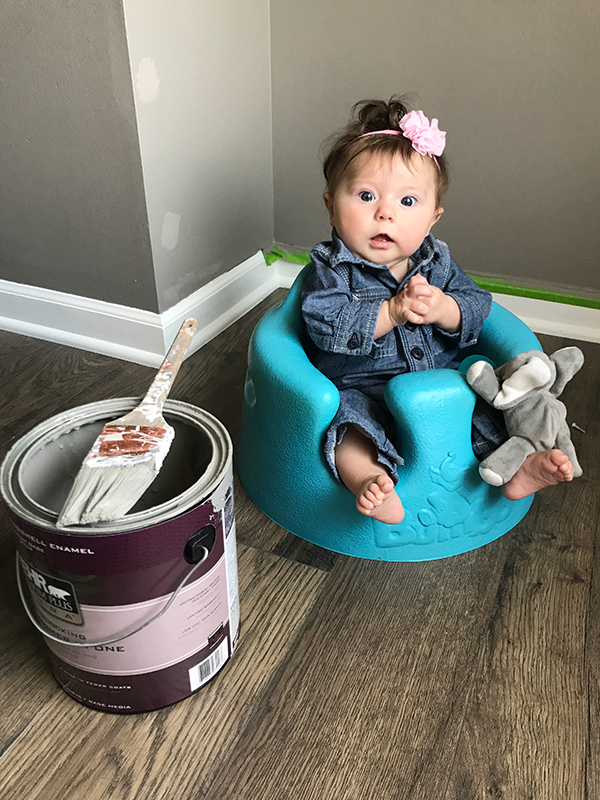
left=0, top=291, right=600, bottom=800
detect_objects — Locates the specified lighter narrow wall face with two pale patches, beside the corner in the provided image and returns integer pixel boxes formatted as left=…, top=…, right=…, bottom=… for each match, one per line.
left=124, top=0, right=274, bottom=311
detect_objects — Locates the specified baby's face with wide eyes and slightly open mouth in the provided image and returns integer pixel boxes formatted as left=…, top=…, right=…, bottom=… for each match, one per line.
left=324, top=152, right=443, bottom=280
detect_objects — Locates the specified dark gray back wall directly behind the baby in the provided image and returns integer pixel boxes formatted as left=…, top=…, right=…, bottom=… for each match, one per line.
left=271, top=0, right=600, bottom=295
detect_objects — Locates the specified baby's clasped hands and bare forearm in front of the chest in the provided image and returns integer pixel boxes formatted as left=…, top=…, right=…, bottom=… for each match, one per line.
left=375, top=274, right=462, bottom=339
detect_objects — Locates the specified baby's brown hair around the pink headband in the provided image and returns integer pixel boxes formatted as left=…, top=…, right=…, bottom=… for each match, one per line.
left=323, top=95, right=450, bottom=208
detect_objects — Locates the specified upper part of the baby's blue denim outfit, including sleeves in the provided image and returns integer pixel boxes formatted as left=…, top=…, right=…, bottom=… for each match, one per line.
left=302, top=230, right=492, bottom=389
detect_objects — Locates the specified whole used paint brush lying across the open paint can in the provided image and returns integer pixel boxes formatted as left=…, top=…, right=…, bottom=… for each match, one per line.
left=56, top=318, right=198, bottom=528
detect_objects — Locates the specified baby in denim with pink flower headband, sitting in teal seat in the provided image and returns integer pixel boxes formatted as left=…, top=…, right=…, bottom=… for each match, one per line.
left=302, top=98, right=573, bottom=524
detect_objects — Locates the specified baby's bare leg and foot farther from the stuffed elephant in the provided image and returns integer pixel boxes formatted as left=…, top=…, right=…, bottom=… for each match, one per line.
left=335, top=425, right=404, bottom=525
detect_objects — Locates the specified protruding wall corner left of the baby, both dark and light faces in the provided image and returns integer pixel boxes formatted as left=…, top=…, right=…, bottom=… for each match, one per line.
left=0, top=0, right=273, bottom=312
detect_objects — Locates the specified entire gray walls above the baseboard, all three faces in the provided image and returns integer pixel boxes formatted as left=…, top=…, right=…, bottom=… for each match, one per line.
left=0, top=0, right=600, bottom=311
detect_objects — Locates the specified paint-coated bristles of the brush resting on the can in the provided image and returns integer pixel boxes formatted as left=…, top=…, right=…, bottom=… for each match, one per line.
left=56, top=461, right=157, bottom=528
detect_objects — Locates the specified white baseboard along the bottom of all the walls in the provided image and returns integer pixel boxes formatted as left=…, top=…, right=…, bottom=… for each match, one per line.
left=0, top=252, right=600, bottom=367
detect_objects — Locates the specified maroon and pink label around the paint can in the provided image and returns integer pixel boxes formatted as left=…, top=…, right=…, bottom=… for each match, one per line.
left=15, top=471, right=240, bottom=713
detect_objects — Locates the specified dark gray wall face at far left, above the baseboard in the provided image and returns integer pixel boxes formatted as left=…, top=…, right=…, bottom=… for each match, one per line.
left=0, top=0, right=158, bottom=311
